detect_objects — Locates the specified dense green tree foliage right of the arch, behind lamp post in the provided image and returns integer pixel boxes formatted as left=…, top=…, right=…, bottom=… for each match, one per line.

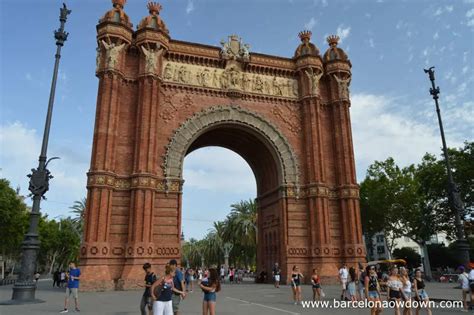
left=360, top=142, right=474, bottom=262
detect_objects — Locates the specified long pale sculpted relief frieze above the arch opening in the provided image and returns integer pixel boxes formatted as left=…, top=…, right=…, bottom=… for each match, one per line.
left=163, top=61, right=298, bottom=99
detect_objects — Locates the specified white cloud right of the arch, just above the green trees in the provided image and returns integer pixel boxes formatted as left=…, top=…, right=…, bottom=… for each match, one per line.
left=351, top=93, right=462, bottom=179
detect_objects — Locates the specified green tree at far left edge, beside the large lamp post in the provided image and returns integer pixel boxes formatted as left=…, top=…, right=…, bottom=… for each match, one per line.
left=0, top=179, right=29, bottom=274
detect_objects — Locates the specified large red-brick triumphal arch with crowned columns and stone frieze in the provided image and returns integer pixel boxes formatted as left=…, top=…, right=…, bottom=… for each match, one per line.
left=80, top=0, right=365, bottom=290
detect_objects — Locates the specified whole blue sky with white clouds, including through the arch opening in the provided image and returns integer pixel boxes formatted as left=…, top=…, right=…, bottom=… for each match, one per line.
left=0, top=0, right=474, bottom=238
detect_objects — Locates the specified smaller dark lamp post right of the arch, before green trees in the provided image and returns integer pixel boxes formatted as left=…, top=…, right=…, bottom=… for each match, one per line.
left=424, top=67, right=469, bottom=266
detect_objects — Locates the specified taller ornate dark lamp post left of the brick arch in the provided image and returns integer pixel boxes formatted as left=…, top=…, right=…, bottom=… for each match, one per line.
left=10, top=4, right=71, bottom=304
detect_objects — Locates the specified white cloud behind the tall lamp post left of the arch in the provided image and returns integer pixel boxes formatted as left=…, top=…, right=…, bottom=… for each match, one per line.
left=0, top=122, right=90, bottom=217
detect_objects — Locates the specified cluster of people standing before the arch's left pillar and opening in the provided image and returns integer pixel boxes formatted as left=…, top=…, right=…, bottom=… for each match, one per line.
left=140, top=259, right=221, bottom=315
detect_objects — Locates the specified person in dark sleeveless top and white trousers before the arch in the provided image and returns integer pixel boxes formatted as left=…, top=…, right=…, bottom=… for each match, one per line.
left=150, top=264, right=186, bottom=315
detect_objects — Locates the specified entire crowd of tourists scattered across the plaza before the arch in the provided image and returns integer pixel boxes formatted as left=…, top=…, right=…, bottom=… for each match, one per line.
left=51, top=259, right=474, bottom=315
